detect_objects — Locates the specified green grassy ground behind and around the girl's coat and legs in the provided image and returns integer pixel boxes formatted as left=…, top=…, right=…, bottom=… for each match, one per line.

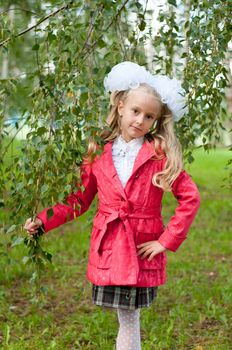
left=0, top=146, right=232, bottom=350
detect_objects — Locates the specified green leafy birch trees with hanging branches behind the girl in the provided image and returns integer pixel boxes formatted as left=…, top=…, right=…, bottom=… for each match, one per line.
left=0, top=0, right=231, bottom=266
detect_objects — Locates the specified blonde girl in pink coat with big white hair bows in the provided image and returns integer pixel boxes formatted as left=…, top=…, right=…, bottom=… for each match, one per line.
left=24, top=62, right=200, bottom=350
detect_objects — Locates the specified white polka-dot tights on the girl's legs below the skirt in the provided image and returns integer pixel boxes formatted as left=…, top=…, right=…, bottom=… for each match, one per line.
left=116, top=309, right=141, bottom=350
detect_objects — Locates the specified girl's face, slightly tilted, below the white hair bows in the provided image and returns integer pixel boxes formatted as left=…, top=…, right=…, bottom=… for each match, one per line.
left=118, top=89, right=161, bottom=142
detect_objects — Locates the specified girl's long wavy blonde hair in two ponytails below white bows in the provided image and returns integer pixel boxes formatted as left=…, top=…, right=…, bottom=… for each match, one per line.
left=85, top=84, right=183, bottom=192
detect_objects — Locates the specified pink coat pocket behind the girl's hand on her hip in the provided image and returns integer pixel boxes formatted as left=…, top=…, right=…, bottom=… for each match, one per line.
left=136, top=232, right=166, bottom=270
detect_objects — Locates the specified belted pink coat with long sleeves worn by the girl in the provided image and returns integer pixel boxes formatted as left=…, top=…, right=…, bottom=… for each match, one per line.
left=37, top=141, right=200, bottom=287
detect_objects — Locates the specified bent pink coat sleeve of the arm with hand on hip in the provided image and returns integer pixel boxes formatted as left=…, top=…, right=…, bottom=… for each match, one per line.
left=158, top=170, right=200, bottom=252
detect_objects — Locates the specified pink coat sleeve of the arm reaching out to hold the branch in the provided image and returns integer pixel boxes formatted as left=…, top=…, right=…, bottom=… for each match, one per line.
left=37, top=164, right=97, bottom=232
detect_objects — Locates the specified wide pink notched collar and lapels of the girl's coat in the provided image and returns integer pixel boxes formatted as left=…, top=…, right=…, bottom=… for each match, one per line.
left=98, top=140, right=158, bottom=199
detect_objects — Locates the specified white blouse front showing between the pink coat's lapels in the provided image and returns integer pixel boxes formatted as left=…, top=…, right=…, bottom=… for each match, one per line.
left=112, top=135, right=144, bottom=187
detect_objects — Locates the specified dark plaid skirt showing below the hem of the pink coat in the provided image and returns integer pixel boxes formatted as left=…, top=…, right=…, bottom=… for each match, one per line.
left=92, top=284, right=158, bottom=310
